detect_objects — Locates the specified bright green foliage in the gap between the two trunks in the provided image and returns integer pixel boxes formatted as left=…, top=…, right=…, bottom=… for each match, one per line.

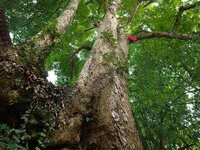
left=46, top=1, right=100, bottom=86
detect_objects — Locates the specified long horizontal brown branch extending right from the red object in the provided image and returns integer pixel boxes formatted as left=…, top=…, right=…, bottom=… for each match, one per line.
left=133, top=32, right=200, bottom=41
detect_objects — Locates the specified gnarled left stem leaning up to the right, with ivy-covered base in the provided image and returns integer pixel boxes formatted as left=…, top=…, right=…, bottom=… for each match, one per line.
left=0, top=0, right=81, bottom=149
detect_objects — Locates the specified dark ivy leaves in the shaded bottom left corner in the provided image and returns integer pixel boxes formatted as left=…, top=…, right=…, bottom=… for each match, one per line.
left=0, top=104, right=60, bottom=150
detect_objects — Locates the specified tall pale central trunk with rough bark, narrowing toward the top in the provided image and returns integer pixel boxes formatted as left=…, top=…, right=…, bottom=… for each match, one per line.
left=77, top=0, right=142, bottom=150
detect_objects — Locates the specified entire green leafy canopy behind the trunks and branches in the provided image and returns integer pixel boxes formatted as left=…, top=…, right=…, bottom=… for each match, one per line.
left=0, top=0, right=200, bottom=150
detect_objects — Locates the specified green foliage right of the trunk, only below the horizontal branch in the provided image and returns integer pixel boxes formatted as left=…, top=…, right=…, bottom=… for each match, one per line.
left=128, top=39, right=200, bottom=149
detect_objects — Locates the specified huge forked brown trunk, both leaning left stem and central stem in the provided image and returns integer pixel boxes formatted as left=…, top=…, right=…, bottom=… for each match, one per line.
left=0, top=0, right=142, bottom=150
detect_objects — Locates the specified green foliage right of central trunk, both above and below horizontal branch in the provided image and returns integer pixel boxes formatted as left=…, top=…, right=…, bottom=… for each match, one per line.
left=127, top=0, right=200, bottom=150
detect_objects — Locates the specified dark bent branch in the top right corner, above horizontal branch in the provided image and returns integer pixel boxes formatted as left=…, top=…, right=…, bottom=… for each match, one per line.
left=173, top=1, right=200, bottom=31
